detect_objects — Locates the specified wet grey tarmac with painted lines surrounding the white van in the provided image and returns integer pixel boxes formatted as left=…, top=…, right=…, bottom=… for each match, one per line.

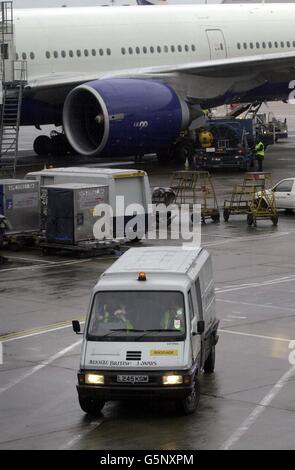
left=0, top=105, right=295, bottom=450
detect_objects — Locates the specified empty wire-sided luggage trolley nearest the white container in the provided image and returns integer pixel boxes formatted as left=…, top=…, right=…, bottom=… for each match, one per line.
left=171, top=171, right=220, bottom=223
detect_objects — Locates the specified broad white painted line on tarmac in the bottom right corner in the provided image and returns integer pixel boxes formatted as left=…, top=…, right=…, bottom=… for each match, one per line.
left=220, top=366, right=295, bottom=450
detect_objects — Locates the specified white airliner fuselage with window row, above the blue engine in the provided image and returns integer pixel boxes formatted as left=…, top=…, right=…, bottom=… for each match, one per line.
left=6, top=4, right=295, bottom=156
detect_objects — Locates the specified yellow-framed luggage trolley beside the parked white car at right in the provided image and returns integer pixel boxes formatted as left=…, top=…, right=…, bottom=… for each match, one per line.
left=223, top=172, right=278, bottom=227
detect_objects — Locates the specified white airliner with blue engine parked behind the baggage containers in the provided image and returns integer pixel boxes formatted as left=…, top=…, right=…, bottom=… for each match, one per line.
left=4, top=4, right=295, bottom=163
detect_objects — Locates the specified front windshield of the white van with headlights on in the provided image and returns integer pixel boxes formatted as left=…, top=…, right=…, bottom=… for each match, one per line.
left=87, top=291, right=185, bottom=341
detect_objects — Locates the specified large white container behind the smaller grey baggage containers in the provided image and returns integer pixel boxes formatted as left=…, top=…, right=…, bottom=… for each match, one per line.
left=26, top=167, right=152, bottom=238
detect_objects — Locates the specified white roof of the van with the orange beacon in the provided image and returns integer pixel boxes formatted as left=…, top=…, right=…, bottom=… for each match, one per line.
left=105, top=246, right=204, bottom=275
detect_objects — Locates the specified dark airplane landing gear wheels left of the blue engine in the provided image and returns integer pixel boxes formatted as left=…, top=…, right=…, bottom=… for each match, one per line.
left=33, top=131, right=74, bottom=157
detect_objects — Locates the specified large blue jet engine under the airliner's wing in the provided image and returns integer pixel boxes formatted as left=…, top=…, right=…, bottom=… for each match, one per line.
left=63, top=78, right=190, bottom=157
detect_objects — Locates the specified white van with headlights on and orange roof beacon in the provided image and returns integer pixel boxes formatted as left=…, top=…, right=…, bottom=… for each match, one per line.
left=73, top=247, right=219, bottom=414
